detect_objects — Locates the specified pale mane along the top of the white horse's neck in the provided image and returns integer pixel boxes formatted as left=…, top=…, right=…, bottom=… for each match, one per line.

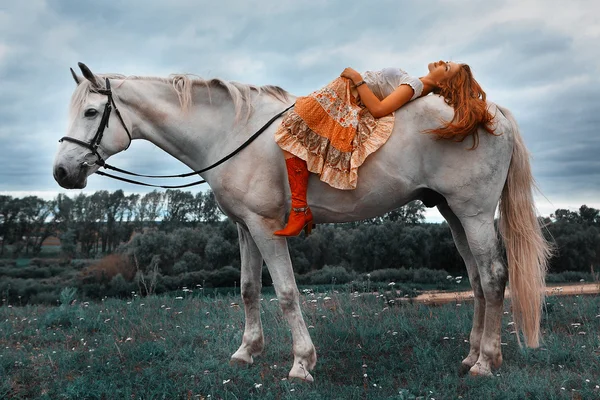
left=71, top=74, right=289, bottom=119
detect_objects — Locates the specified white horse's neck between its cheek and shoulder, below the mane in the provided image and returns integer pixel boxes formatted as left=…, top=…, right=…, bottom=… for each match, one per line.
left=117, top=80, right=251, bottom=169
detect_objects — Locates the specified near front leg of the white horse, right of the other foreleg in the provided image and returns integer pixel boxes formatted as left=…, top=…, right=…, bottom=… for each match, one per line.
left=248, top=218, right=317, bottom=382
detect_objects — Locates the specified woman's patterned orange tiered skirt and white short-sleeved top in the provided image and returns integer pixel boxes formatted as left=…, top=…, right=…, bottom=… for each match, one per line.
left=275, top=68, right=423, bottom=190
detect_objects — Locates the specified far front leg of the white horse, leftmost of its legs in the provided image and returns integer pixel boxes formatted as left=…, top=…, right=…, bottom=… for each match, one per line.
left=231, top=223, right=264, bottom=365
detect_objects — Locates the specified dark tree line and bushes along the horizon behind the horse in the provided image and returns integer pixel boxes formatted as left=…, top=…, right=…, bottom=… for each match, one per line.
left=0, top=190, right=600, bottom=274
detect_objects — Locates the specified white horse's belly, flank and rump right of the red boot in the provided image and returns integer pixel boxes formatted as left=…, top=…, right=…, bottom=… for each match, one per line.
left=309, top=96, right=512, bottom=222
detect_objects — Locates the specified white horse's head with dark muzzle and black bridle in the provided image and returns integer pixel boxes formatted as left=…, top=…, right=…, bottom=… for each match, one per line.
left=54, top=63, right=131, bottom=189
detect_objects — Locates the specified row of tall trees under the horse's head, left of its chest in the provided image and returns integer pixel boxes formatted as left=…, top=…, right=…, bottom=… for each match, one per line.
left=0, top=190, right=223, bottom=258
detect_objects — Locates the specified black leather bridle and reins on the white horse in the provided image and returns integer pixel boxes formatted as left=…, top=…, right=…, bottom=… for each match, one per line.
left=59, top=78, right=295, bottom=189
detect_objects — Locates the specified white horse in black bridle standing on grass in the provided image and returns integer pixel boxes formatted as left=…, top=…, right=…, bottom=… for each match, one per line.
left=54, top=63, right=550, bottom=381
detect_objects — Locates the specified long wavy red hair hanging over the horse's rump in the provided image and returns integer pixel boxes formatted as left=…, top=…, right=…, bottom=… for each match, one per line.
left=425, top=64, right=496, bottom=150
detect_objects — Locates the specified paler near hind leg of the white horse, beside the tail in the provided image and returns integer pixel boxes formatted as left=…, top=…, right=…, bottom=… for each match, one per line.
left=457, top=211, right=508, bottom=375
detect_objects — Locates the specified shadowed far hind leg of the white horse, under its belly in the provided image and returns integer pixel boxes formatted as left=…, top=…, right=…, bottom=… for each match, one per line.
left=438, top=203, right=485, bottom=374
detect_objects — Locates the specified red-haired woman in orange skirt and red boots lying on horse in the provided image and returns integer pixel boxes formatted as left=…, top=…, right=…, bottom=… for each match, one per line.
left=275, top=61, right=494, bottom=236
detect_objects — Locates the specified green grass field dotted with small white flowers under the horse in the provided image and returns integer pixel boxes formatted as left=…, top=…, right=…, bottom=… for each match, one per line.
left=0, top=291, right=600, bottom=399
